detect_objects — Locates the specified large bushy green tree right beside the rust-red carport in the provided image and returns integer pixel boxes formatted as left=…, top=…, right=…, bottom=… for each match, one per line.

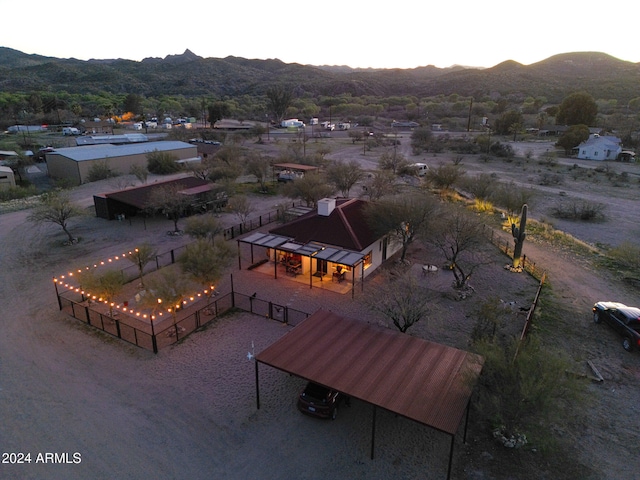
left=471, top=335, right=588, bottom=447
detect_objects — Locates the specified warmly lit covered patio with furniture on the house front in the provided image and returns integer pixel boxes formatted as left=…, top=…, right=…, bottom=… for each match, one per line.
left=238, top=232, right=365, bottom=296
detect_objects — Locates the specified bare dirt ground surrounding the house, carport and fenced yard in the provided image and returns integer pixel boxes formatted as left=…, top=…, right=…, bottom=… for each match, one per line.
left=0, top=135, right=640, bottom=480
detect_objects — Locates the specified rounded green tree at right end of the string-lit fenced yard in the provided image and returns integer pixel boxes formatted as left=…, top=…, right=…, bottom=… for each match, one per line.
left=178, top=238, right=234, bottom=297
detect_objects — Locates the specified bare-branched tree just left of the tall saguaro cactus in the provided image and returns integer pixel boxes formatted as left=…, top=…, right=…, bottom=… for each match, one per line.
left=427, top=206, right=488, bottom=289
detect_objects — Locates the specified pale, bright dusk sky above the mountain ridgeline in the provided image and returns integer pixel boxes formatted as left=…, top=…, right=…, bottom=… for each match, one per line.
left=0, top=0, right=640, bottom=68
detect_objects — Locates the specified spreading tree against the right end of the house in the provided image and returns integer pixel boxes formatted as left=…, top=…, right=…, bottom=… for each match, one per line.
left=364, top=193, right=440, bottom=262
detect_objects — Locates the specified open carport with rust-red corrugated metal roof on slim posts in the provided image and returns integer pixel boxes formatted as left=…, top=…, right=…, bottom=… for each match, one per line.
left=255, top=310, right=484, bottom=478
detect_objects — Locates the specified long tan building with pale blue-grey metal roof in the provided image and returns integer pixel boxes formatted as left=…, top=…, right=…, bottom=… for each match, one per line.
left=46, top=141, right=199, bottom=185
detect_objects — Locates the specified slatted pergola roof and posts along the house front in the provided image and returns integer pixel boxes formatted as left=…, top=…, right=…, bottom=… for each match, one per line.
left=238, top=233, right=364, bottom=296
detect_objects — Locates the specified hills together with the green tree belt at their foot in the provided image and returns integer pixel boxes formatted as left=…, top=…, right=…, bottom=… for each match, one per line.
left=0, top=48, right=640, bottom=148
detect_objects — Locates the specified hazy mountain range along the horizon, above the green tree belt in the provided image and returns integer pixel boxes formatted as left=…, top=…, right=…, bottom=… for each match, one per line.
left=0, top=47, right=640, bottom=104
